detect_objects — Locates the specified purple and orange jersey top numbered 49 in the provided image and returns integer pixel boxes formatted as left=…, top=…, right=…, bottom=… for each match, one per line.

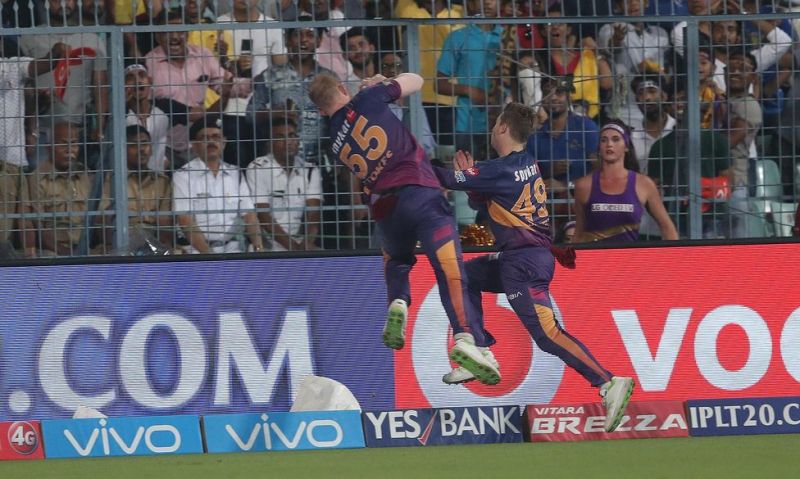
left=435, top=150, right=551, bottom=251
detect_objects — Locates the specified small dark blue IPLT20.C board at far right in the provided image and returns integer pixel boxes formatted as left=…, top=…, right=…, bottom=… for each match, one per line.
left=686, top=397, right=800, bottom=436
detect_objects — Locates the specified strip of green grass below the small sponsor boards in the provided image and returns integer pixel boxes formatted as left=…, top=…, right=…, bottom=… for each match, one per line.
left=0, top=435, right=800, bottom=479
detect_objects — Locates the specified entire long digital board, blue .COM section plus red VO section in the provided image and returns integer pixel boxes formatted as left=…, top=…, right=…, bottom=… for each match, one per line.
left=0, top=244, right=800, bottom=421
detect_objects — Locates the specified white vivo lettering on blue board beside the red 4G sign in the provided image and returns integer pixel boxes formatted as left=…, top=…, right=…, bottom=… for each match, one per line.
left=64, top=419, right=181, bottom=457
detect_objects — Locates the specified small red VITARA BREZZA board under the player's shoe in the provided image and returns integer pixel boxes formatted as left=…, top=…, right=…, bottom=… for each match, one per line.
left=526, top=401, right=689, bottom=442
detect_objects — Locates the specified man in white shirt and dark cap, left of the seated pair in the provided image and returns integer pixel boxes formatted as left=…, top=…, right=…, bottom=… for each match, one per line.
left=172, top=116, right=263, bottom=253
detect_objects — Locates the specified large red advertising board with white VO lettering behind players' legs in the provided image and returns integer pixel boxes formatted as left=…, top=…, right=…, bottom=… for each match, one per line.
left=395, top=244, right=800, bottom=408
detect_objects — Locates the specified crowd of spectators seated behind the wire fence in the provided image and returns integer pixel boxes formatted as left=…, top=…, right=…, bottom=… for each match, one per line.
left=0, top=0, right=800, bottom=257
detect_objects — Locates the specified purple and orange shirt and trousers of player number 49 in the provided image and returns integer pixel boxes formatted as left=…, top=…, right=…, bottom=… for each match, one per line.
left=436, top=151, right=612, bottom=386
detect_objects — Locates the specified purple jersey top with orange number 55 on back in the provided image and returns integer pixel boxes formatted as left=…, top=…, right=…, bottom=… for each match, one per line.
left=330, top=81, right=441, bottom=194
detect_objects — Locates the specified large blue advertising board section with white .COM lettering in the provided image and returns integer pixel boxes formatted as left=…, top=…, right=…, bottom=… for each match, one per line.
left=0, top=257, right=395, bottom=420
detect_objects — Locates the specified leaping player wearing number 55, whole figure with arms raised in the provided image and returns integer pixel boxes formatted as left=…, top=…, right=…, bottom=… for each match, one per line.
left=309, top=73, right=500, bottom=384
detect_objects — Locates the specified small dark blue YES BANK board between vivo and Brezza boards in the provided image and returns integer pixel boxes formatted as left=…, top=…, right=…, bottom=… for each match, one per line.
left=364, top=406, right=522, bottom=447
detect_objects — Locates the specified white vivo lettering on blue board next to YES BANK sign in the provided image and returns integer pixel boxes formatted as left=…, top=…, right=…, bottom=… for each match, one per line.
left=225, top=414, right=344, bottom=451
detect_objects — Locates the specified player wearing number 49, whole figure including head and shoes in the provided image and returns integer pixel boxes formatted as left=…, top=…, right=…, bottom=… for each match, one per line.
left=436, top=103, right=633, bottom=431
